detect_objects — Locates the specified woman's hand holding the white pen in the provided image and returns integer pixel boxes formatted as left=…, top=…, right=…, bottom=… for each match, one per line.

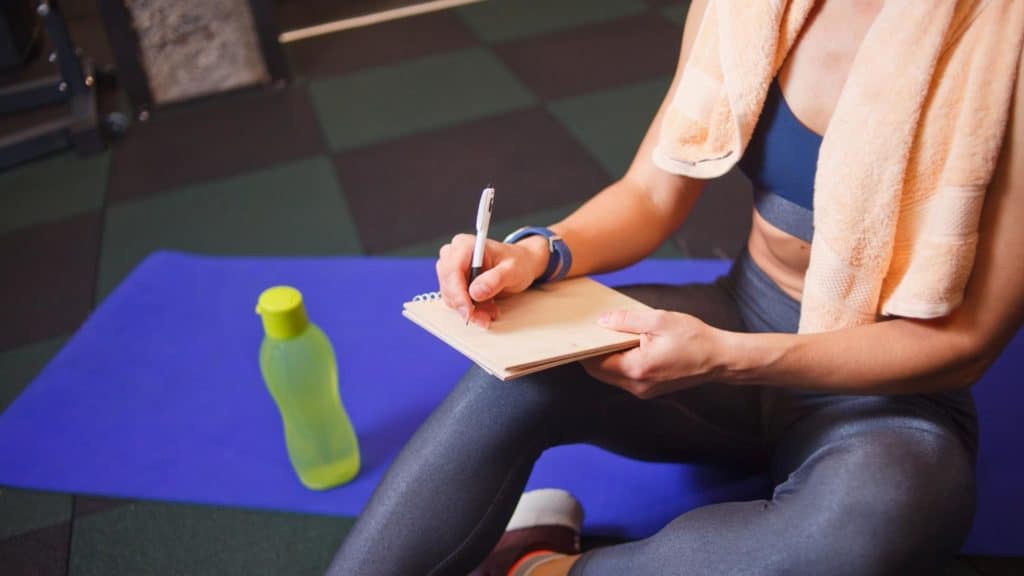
left=436, top=234, right=548, bottom=328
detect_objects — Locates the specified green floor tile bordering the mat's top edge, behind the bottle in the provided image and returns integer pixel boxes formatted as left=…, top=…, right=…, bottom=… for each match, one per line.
left=98, top=157, right=361, bottom=297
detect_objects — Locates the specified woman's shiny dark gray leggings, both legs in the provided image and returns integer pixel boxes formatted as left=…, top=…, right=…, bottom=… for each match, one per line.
left=329, top=255, right=977, bottom=576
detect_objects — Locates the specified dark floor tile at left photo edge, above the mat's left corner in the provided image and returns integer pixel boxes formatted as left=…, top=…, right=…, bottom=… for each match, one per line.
left=0, top=210, right=100, bottom=349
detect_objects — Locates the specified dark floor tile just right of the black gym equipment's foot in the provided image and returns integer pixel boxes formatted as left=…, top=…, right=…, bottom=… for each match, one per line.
left=108, top=84, right=324, bottom=202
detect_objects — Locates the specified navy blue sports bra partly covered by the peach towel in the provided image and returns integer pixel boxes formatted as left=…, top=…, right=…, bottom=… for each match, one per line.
left=739, top=79, right=821, bottom=242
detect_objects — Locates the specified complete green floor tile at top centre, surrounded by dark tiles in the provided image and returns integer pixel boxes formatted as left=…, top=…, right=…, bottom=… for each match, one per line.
left=309, top=48, right=535, bottom=151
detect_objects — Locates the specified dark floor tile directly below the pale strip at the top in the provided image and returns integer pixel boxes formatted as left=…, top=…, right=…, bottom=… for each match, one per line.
left=285, top=10, right=477, bottom=78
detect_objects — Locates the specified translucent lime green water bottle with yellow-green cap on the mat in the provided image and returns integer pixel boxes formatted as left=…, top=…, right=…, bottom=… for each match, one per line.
left=256, top=286, right=359, bottom=490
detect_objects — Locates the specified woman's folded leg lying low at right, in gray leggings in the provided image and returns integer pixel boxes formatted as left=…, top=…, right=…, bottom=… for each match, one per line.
left=569, top=398, right=974, bottom=576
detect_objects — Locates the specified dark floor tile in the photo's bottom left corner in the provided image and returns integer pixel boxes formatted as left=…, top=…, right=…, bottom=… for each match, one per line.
left=0, top=522, right=71, bottom=576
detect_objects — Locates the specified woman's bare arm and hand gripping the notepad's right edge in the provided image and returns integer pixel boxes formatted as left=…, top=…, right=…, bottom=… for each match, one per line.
left=585, top=48, right=1024, bottom=398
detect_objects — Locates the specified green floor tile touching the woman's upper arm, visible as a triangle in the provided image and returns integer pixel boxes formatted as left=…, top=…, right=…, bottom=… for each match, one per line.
left=548, top=78, right=672, bottom=178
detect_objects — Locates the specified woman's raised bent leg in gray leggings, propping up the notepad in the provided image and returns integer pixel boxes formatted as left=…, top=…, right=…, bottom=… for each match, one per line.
left=329, top=285, right=767, bottom=576
